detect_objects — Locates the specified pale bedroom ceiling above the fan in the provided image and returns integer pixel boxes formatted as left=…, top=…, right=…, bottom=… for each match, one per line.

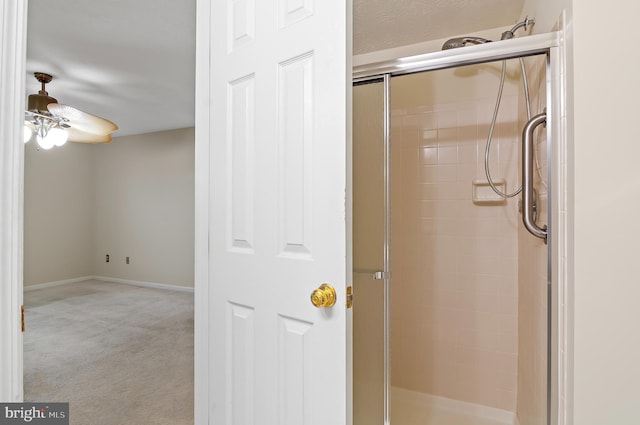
left=26, top=0, right=195, bottom=137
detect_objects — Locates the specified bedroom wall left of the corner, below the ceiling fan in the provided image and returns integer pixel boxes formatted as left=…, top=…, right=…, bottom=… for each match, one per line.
left=24, top=141, right=94, bottom=286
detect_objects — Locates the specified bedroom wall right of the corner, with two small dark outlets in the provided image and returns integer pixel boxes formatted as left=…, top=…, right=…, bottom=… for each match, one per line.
left=93, top=128, right=194, bottom=286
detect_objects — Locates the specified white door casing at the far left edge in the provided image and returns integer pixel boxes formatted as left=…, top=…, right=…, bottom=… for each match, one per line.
left=0, top=0, right=27, bottom=402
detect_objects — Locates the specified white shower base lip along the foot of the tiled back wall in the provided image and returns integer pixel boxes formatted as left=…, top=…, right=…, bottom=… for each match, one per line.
left=391, top=387, right=518, bottom=425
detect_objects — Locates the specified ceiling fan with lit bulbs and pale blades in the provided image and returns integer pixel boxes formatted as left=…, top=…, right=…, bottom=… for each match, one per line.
left=24, top=72, right=118, bottom=149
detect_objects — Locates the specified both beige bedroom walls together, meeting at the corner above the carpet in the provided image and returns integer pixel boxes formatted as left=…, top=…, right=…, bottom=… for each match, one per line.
left=25, top=128, right=194, bottom=286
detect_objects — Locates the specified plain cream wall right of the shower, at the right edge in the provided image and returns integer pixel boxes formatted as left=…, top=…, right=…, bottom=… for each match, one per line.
left=524, top=0, right=640, bottom=425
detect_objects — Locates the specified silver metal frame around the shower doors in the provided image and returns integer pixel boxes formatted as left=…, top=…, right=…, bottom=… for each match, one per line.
left=353, top=32, right=567, bottom=425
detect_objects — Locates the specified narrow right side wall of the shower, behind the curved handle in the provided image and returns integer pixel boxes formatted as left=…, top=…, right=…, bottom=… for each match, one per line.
left=517, top=56, right=548, bottom=425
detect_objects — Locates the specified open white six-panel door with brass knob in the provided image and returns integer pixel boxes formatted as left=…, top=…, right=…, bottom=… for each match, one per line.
left=208, top=0, right=351, bottom=425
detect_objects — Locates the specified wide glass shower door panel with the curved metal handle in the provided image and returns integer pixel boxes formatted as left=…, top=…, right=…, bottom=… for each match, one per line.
left=390, top=55, right=548, bottom=425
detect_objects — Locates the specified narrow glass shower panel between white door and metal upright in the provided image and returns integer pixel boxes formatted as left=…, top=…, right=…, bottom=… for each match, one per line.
left=353, top=81, right=387, bottom=425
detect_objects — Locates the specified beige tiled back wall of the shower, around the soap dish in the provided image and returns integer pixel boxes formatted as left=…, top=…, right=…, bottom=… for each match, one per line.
left=391, top=64, right=521, bottom=411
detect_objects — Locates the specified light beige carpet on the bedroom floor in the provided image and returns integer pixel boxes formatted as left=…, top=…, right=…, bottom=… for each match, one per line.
left=24, top=281, right=193, bottom=425
